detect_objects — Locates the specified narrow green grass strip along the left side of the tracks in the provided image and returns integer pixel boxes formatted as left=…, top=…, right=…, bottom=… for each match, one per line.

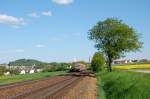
left=0, top=71, right=67, bottom=85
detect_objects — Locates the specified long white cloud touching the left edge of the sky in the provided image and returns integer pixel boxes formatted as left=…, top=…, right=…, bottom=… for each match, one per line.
left=0, top=14, right=26, bottom=27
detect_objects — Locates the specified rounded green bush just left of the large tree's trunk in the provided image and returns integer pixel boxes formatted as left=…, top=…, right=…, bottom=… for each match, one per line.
left=91, top=52, right=105, bottom=72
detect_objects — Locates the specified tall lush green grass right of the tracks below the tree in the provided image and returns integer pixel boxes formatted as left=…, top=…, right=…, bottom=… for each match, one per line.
left=96, top=71, right=150, bottom=99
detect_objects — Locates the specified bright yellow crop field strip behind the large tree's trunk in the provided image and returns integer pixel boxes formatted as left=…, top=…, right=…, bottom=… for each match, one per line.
left=112, top=64, right=150, bottom=70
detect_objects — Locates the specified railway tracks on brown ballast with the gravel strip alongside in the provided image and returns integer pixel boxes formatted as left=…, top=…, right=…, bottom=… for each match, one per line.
left=0, top=73, right=97, bottom=99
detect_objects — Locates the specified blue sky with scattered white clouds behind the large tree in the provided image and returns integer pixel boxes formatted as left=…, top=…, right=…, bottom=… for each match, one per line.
left=0, top=0, right=150, bottom=63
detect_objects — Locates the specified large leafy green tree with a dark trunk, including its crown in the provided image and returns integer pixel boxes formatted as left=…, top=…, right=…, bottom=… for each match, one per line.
left=88, top=18, right=142, bottom=71
